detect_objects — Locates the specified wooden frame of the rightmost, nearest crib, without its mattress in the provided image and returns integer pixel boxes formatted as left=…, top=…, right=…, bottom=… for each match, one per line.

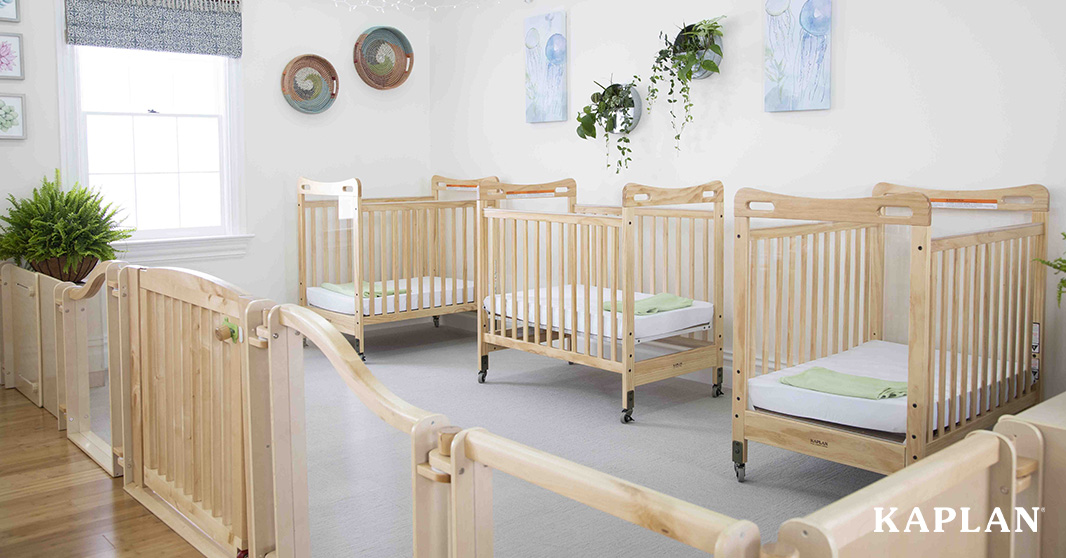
left=732, top=184, right=1048, bottom=481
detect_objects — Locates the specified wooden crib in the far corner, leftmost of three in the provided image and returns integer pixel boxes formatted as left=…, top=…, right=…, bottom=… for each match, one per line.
left=297, top=176, right=496, bottom=357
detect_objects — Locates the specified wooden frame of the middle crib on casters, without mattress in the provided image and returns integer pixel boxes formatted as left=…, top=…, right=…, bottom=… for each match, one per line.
left=478, top=179, right=725, bottom=424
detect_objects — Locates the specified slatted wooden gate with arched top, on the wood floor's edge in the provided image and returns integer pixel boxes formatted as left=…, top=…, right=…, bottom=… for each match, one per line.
left=118, top=267, right=251, bottom=556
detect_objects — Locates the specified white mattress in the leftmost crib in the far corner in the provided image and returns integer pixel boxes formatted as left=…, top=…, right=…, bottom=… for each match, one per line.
left=307, top=276, right=477, bottom=316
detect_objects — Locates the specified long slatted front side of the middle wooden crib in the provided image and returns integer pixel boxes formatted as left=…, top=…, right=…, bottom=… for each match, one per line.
left=482, top=208, right=623, bottom=372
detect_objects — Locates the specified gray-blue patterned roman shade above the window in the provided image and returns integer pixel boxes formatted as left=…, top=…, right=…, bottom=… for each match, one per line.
left=66, top=0, right=241, bottom=58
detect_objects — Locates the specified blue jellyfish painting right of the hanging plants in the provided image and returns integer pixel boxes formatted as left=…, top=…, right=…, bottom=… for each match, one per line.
left=763, top=0, right=833, bottom=112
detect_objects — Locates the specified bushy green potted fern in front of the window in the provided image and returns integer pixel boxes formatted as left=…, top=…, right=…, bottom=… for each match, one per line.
left=0, top=171, right=133, bottom=282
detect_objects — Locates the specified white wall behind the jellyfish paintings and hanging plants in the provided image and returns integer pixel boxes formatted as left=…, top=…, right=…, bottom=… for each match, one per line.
left=431, top=0, right=1066, bottom=394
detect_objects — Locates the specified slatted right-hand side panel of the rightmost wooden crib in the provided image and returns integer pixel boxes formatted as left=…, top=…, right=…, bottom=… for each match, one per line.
left=927, top=223, right=1046, bottom=445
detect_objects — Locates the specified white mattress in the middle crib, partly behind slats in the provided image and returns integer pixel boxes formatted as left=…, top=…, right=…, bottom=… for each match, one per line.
left=483, top=285, right=714, bottom=341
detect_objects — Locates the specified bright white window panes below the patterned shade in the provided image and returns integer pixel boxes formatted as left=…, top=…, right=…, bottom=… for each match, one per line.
left=74, top=46, right=238, bottom=240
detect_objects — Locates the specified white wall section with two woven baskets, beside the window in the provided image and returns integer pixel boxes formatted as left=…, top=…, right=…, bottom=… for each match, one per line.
left=188, top=0, right=431, bottom=302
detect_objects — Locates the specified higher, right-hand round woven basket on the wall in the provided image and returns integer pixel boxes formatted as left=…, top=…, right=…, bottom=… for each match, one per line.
left=354, top=27, right=415, bottom=90
